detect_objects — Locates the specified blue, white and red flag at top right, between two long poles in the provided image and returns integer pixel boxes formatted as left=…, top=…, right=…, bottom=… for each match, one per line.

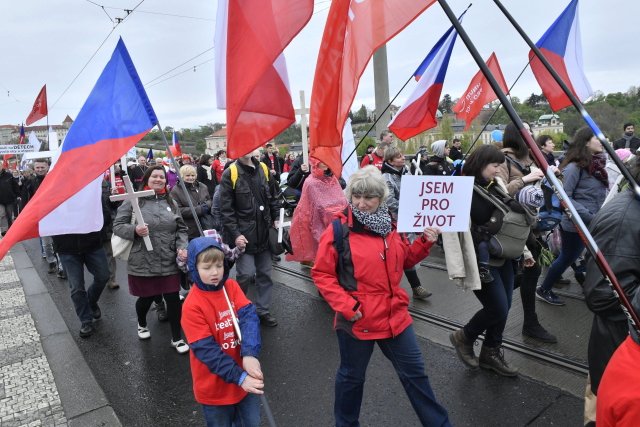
left=529, top=0, right=593, bottom=111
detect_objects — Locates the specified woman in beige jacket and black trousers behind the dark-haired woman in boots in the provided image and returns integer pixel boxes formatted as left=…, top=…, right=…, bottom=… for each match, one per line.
left=498, top=122, right=556, bottom=343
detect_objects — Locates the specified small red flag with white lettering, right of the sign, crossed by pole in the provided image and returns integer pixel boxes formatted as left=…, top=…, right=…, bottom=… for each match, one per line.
left=453, top=52, right=509, bottom=130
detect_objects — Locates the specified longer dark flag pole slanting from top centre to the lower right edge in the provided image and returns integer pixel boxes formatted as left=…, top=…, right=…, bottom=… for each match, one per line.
left=438, top=0, right=640, bottom=334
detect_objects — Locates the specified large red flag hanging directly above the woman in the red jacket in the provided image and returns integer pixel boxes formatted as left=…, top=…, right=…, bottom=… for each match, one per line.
left=309, top=0, right=435, bottom=175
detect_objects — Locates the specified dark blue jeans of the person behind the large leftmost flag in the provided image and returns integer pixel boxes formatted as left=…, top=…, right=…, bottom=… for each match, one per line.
left=59, top=247, right=109, bottom=325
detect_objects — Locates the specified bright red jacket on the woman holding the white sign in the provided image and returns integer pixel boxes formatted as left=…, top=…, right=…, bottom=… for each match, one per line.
left=311, top=209, right=433, bottom=340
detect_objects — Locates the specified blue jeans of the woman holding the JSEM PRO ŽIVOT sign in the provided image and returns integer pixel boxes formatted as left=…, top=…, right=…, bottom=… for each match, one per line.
left=334, top=326, right=451, bottom=427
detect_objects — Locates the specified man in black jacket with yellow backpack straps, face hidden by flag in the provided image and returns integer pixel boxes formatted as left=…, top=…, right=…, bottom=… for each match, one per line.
left=220, top=150, right=279, bottom=327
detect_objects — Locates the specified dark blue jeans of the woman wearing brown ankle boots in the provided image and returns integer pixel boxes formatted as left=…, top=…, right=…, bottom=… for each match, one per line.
left=463, top=260, right=514, bottom=347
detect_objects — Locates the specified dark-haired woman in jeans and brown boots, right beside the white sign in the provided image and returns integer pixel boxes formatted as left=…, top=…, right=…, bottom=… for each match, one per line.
left=449, top=145, right=528, bottom=377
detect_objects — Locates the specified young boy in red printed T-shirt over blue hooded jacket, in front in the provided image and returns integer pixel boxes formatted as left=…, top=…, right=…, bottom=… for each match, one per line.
left=182, top=237, right=264, bottom=427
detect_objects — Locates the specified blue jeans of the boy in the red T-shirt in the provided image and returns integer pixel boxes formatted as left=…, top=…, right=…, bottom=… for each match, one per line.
left=202, top=393, right=260, bottom=427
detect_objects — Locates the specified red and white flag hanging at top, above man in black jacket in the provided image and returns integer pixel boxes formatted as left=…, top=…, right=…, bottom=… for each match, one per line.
left=214, top=0, right=313, bottom=158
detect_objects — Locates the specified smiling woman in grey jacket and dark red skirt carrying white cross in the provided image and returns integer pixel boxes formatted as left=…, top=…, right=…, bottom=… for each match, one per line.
left=113, top=166, right=189, bottom=353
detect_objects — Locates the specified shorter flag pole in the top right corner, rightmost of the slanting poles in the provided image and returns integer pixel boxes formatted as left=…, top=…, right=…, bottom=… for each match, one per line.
left=493, top=0, right=640, bottom=199
